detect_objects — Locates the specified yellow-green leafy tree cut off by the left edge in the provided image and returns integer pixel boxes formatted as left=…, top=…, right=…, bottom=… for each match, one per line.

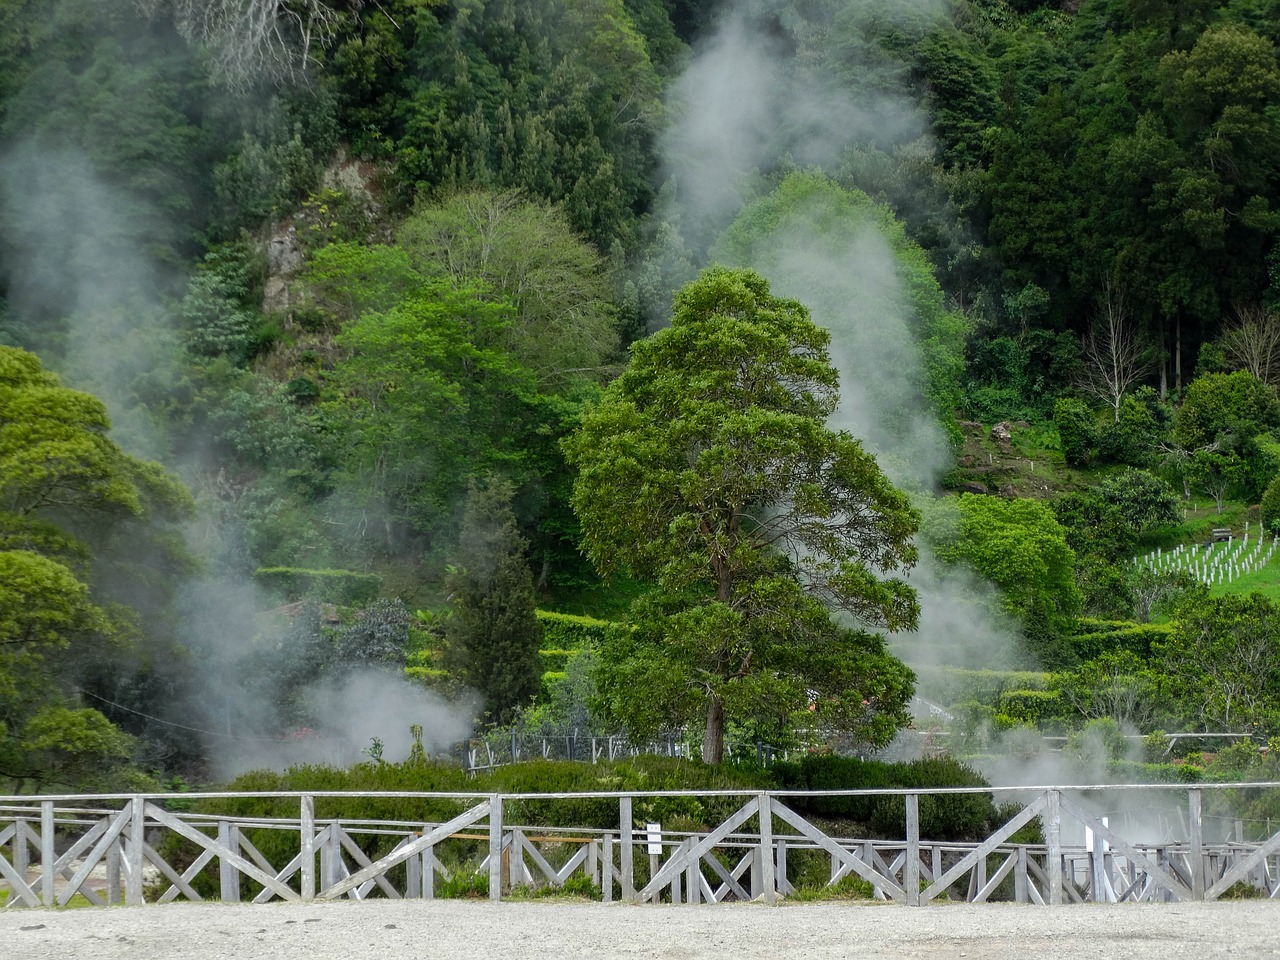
left=0, top=347, right=189, bottom=788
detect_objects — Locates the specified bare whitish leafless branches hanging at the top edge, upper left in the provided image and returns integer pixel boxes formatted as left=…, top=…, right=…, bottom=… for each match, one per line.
left=138, top=0, right=345, bottom=93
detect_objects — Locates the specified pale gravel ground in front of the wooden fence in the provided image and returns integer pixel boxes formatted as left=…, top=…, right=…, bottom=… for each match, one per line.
left=0, top=900, right=1280, bottom=960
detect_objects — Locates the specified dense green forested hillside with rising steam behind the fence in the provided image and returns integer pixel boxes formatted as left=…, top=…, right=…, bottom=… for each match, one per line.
left=0, top=0, right=1280, bottom=792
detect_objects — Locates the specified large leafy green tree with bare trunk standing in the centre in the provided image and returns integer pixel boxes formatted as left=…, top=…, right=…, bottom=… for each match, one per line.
left=566, top=268, right=918, bottom=763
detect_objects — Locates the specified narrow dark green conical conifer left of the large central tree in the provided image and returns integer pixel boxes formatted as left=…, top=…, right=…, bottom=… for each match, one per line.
left=445, top=476, right=543, bottom=723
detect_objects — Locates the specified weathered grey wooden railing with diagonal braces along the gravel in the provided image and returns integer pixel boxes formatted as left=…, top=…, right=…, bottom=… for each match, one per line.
left=0, top=783, right=1280, bottom=909
